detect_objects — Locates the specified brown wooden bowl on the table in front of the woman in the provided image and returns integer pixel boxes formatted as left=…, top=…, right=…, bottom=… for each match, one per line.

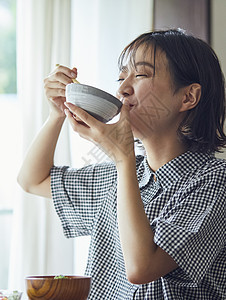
left=25, top=276, right=91, bottom=300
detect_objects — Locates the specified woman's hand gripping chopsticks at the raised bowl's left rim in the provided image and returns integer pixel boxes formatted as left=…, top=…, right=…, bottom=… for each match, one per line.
left=44, top=65, right=77, bottom=117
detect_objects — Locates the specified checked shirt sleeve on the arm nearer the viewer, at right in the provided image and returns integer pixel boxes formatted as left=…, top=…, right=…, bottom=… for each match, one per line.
left=151, top=168, right=226, bottom=283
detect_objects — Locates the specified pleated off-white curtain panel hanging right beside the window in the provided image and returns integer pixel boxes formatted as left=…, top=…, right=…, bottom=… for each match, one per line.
left=9, top=0, right=74, bottom=290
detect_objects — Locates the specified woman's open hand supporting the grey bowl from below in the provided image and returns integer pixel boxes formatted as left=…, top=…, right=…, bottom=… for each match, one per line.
left=65, top=102, right=134, bottom=164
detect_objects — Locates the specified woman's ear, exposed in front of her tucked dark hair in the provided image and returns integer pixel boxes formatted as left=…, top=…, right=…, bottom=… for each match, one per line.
left=180, top=83, right=202, bottom=112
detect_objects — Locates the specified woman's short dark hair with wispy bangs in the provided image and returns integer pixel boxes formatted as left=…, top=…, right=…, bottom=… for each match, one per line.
left=119, top=29, right=226, bottom=153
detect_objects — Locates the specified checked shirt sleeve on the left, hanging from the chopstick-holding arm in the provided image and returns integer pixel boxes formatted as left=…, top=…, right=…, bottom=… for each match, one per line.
left=51, top=163, right=116, bottom=238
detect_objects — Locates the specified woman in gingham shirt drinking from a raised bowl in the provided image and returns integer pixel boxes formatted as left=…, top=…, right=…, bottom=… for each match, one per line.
left=18, top=30, right=226, bottom=300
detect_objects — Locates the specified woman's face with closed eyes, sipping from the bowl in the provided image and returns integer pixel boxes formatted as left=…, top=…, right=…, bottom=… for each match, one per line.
left=117, top=46, right=183, bottom=140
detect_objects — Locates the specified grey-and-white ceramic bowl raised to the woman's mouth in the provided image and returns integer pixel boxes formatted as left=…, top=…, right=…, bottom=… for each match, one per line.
left=65, top=83, right=122, bottom=123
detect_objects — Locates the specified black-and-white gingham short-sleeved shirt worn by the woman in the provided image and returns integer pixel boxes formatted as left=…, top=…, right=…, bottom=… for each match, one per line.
left=51, top=152, right=226, bottom=300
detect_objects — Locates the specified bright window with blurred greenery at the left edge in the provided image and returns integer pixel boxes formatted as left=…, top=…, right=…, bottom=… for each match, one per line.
left=0, top=0, right=22, bottom=289
